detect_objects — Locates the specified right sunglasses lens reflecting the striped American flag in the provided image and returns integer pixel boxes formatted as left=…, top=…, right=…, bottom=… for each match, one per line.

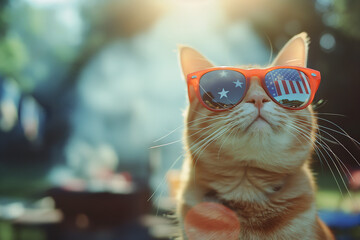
left=265, top=68, right=311, bottom=109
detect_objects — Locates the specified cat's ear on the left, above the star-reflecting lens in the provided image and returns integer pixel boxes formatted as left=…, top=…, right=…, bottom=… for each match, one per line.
left=178, top=45, right=214, bottom=101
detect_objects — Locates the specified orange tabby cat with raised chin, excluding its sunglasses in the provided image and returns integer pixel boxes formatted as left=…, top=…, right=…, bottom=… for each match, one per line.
left=177, top=33, right=334, bottom=240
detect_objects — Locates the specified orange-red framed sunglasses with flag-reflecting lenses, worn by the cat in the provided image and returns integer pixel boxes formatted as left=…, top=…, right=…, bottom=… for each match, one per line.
left=187, top=66, right=321, bottom=111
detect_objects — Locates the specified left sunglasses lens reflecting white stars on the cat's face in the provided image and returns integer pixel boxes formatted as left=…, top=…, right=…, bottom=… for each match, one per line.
left=199, top=70, right=246, bottom=110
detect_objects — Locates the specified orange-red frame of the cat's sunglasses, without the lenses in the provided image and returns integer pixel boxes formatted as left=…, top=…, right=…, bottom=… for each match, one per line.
left=187, top=66, right=321, bottom=112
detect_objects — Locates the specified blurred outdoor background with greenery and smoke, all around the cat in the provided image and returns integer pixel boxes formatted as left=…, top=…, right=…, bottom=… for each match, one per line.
left=0, top=0, right=360, bottom=240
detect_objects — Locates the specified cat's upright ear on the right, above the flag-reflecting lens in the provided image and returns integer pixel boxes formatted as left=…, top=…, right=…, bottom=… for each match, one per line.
left=272, top=32, right=310, bottom=67
